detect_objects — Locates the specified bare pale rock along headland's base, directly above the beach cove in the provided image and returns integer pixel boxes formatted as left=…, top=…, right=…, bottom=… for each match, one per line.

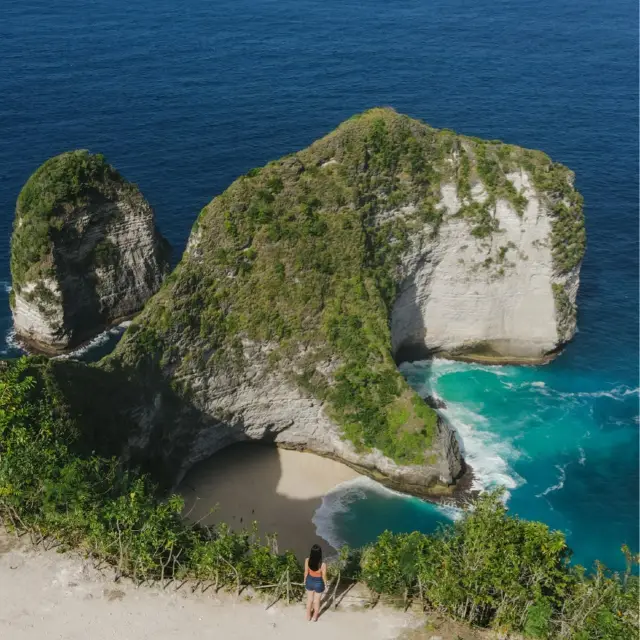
left=121, top=341, right=463, bottom=495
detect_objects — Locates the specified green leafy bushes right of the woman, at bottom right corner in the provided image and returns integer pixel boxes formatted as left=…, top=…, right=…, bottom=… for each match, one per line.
left=361, top=492, right=639, bottom=640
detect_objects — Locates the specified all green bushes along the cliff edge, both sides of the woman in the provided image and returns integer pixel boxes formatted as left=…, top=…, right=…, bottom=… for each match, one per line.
left=0, top=359, right=639, bottom=640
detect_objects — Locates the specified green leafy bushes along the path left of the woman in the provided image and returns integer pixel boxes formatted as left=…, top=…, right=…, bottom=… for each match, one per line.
left=0, top=359, right=302, bottom=589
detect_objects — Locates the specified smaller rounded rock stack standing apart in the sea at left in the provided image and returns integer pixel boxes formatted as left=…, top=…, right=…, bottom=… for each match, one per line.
left=10, top=150, right=169, bottom=354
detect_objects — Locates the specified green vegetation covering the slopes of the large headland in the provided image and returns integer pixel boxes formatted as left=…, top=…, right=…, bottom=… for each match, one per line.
left=115, top=109, right=577, bottom=463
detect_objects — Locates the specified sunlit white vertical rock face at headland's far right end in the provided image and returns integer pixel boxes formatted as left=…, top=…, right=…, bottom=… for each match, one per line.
left=392, top=171, right=578, bottom=360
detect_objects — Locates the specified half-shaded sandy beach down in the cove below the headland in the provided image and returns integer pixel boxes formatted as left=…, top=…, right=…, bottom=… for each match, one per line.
left=179, top=444, right=359, bottom=558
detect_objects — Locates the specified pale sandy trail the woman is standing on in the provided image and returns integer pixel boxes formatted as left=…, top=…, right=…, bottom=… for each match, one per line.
left=0, top=534, right=418, bottom=640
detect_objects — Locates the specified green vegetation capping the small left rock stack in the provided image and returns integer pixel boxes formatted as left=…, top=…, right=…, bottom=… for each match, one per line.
left=11, top=150, right=136, bottom=291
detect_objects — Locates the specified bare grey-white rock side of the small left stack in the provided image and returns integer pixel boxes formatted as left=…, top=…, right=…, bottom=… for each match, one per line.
left=12, top=191, right=168, bottom=352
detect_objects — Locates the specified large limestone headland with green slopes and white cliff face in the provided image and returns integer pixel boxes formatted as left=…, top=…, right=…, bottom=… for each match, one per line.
left=102, top=109, right=584, bottom=495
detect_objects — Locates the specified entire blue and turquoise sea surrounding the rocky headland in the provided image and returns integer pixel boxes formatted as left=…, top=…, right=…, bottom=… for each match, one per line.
left=0, top=0, right=639, bottom=568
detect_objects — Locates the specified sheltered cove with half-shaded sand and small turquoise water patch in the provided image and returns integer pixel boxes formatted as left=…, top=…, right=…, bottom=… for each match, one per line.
left=178, top=443, right=461, bottom=559
